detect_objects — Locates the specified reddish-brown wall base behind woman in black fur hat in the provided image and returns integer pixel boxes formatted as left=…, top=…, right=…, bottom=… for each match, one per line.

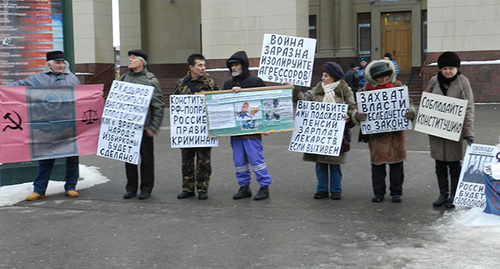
left=422, top=51, right=500, bottom=103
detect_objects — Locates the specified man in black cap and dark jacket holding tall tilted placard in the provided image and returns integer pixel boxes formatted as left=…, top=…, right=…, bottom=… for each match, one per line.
left=119, top=50, right=165, bottom=199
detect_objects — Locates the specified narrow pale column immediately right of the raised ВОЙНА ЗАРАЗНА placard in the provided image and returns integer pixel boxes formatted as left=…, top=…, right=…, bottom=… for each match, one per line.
left=316, top=0, right=335, bottom=58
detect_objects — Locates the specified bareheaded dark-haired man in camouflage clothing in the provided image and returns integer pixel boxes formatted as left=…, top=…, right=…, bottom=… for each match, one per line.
left=173, top=54, right=219, bottom=200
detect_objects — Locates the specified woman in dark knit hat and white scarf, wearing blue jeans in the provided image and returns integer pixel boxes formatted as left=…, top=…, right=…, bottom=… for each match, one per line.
left=294, top=62, right=356, bottom=200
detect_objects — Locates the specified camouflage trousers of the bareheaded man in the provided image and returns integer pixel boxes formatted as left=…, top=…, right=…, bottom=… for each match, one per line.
left=181, top=148, right=212, bottom=193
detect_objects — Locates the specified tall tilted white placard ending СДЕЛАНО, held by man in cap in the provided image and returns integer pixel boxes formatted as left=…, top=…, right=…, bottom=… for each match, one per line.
left=97, top=80, right=154, bottom=164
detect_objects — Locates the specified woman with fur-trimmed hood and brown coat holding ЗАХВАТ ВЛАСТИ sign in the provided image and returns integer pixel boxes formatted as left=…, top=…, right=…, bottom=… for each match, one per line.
left=356, top=60, right=415, bottom=203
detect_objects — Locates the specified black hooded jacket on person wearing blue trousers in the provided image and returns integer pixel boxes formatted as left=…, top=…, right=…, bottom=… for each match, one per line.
left=224, top=51, right=266, bottom=139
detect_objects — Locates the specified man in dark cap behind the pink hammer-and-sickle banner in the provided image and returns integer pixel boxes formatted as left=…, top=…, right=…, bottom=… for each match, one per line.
left=7, top=50, right=84, bottom=201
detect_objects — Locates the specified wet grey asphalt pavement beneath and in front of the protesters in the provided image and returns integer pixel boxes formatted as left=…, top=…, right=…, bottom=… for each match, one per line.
left=0, top=105, right=500, bottom=268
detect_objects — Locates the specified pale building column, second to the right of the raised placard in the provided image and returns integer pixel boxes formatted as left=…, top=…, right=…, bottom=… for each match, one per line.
left=335, top=0, right=357, bottom=57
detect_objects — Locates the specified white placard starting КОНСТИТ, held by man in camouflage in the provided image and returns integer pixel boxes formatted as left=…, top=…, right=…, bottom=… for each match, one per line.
left=170, top=94, right=219, bottom=148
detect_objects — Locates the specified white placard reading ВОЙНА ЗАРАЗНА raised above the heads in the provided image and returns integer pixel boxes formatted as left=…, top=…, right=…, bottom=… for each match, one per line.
left=258, top=34, right=316, bottom=87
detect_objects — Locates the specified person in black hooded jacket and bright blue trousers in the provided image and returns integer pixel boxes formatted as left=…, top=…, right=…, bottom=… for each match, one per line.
left=224, top=51, right=271, bottom=200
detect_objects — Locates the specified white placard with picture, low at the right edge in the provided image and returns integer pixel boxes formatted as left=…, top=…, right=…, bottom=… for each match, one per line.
left=453, top=144, right=500, bottom=208
